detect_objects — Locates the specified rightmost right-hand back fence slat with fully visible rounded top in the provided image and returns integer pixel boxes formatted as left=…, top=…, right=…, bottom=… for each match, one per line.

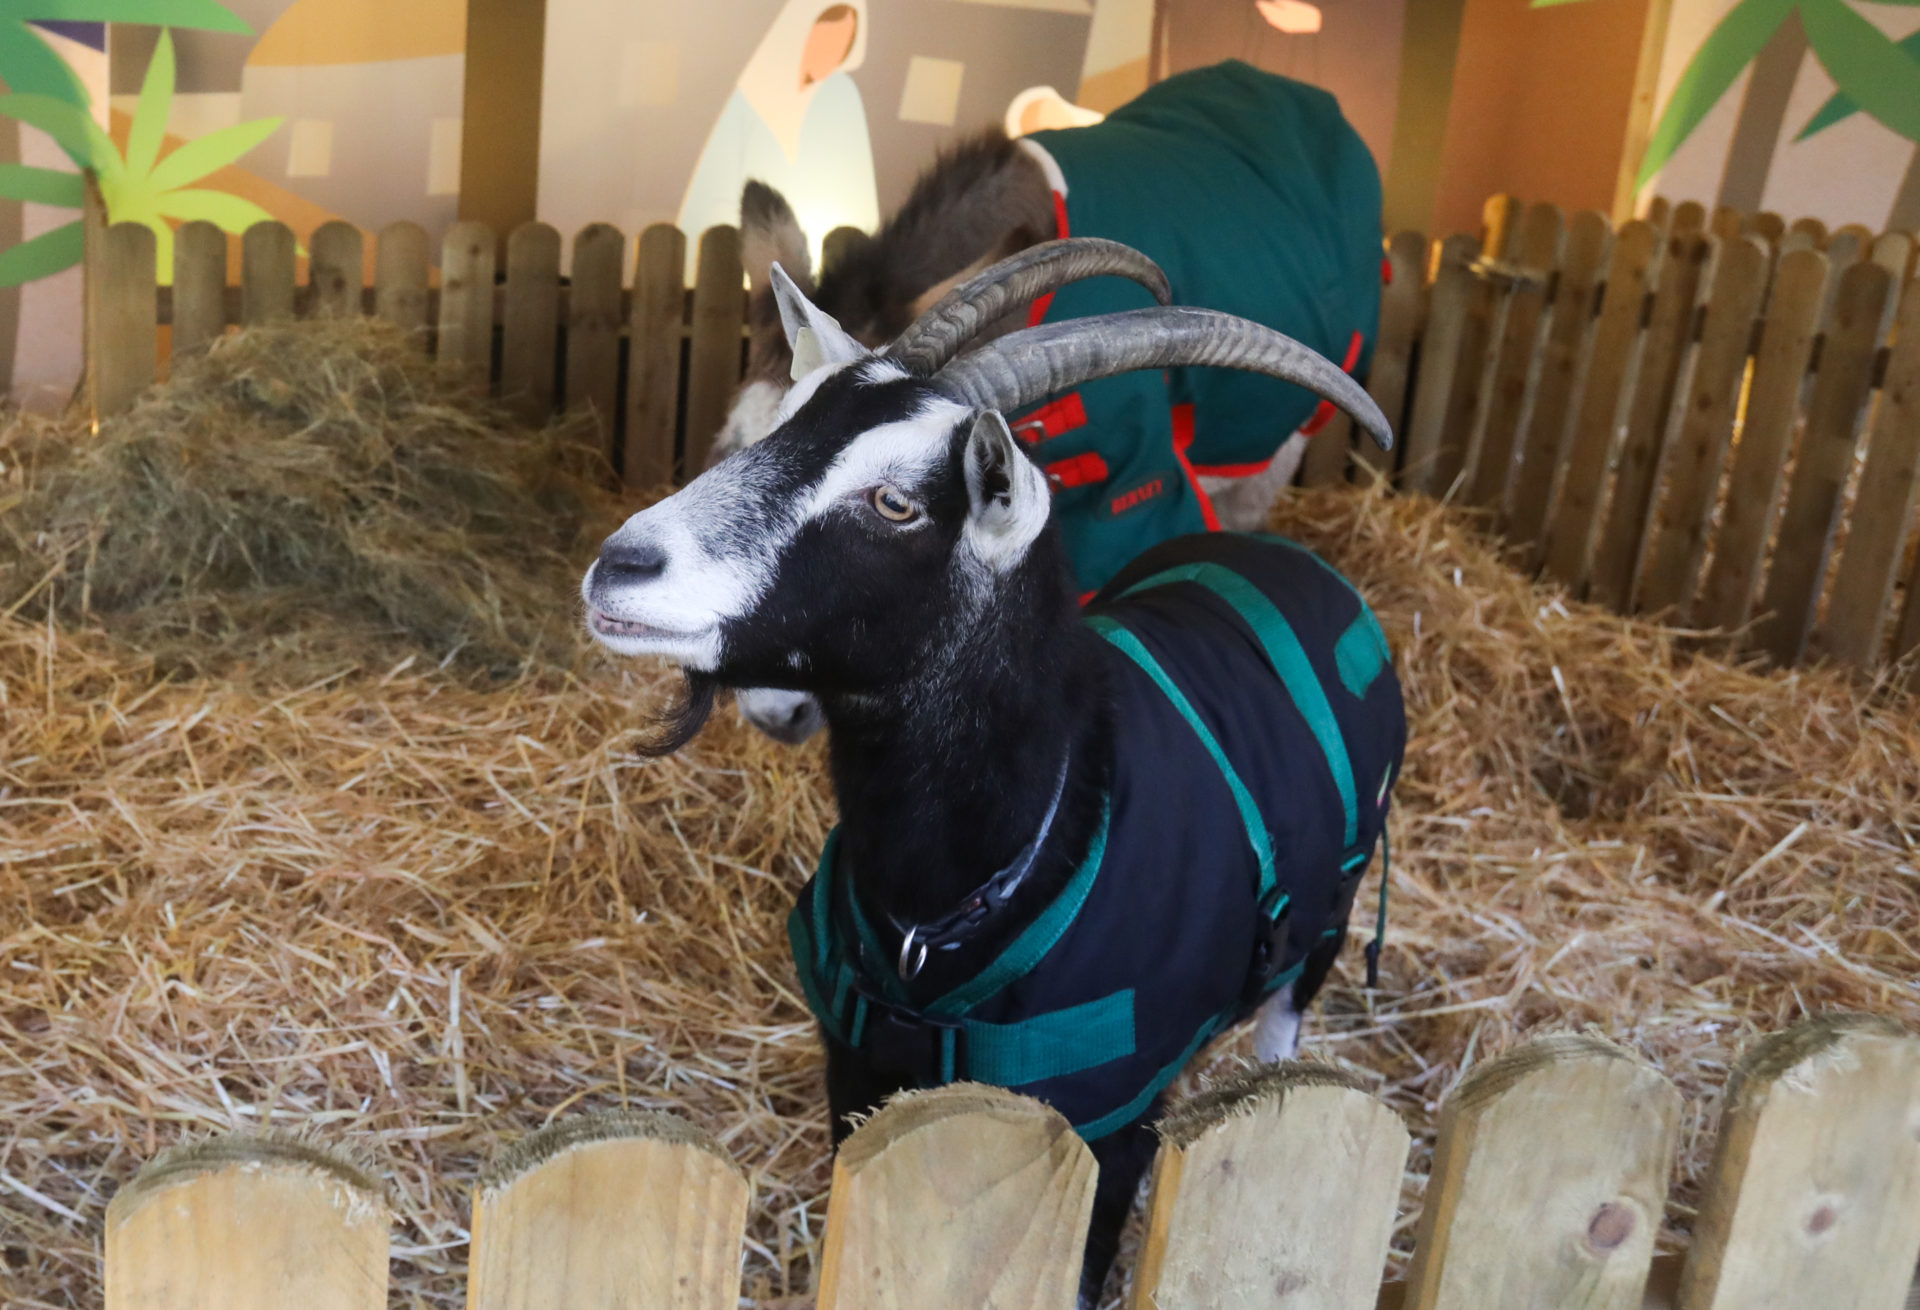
left=1753, top=263, right=1893, bottom=665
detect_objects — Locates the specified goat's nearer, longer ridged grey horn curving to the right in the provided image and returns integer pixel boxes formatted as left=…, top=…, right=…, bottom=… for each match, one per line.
left=933, top=305, right=1394, bottom=449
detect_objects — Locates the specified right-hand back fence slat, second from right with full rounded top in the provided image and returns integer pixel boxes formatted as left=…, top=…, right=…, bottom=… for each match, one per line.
left=1686, top=248, right=1828, bottom=632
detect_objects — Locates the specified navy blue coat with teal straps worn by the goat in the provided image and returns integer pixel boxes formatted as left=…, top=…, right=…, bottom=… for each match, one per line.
left=789, top=534, right=1407, bottom=1141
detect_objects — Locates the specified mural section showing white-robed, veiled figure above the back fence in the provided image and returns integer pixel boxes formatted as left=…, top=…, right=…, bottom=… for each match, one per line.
left=540, top=0, right=1113, bottom=268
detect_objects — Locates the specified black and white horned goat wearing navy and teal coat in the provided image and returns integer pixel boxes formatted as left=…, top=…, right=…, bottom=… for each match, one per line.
left=582, top=242, right=1405, bottom=1302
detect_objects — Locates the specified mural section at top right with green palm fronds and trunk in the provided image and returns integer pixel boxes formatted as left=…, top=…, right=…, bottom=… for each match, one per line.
left=1640, top=0, right=1920, bottom=230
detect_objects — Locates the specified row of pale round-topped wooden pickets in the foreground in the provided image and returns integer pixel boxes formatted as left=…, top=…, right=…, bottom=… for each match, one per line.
left=106, top=1016, right=1920, bottom=1310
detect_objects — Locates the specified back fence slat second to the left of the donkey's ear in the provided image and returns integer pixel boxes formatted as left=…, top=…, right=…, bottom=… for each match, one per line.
left=620, top=223, right=687, bottom=488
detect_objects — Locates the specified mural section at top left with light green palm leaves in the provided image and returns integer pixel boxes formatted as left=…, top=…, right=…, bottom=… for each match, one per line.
left=0, top=0, right=467, bottom=407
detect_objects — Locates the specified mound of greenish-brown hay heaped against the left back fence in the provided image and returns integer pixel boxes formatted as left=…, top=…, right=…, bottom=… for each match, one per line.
left=0, top=319, right=611, bottom=674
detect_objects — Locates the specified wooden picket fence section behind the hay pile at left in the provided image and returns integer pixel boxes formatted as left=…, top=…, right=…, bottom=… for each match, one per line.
left=86, top=191, right=747, bottom=486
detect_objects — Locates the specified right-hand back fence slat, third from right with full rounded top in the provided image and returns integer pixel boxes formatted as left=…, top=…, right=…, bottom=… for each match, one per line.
left=1638, top=236, right=1768, bottom=613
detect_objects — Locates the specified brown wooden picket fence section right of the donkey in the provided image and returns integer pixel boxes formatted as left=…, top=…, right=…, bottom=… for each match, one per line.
left=1302, top=196, right=1920, bottom=667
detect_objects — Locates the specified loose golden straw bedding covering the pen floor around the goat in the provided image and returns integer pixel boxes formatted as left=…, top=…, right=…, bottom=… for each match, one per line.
left=0, top=332, right=1920, bottom=1306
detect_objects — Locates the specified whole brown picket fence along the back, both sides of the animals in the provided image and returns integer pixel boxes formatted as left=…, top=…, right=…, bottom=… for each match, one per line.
left=88, top=196, right=1920, bottom=668
